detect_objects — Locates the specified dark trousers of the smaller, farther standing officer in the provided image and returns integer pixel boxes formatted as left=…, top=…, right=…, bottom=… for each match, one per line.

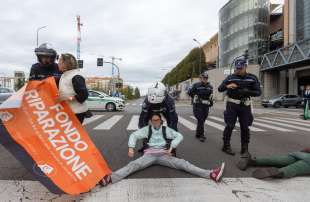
left=193, top=103, right=209, bottom=137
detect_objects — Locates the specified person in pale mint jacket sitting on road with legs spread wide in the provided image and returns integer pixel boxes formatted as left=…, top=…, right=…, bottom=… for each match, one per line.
left=99, top=113, right=225, bottom=186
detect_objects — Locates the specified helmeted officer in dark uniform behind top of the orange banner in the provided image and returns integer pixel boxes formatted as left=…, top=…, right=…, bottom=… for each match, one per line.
left=29, top=43, right=61, bottom=83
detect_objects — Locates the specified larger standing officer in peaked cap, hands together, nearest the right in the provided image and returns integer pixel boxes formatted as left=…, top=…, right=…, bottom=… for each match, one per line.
left=218, top=58, right=261, bottom=158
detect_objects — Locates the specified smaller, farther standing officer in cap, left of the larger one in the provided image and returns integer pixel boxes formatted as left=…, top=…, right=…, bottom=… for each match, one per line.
left=188, top=72, right=213, bottom=142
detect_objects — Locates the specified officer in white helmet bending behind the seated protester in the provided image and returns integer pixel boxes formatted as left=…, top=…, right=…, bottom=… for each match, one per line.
left=139, top=82, right=178, bottom=131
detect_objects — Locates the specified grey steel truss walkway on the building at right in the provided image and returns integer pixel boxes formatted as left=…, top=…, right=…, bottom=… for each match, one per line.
left=261, top=39, right=310, bottom=71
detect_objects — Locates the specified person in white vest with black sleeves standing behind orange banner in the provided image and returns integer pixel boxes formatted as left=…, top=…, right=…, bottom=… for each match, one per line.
left=58, top=53, right=91, bottom=123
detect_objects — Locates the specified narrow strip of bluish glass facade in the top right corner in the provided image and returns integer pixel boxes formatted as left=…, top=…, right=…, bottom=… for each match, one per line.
left=295, top=0, right=310, bottom=41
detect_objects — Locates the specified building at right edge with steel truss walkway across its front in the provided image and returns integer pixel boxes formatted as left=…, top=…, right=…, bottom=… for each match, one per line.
left=261, top=0, right=310, bottom=97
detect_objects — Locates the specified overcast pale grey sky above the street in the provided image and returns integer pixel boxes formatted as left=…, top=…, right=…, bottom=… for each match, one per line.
left=0, top=0, right=280, bottom=92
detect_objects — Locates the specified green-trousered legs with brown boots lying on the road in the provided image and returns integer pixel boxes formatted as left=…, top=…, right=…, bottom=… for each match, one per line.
left=237, top=148, right=310, bottom=179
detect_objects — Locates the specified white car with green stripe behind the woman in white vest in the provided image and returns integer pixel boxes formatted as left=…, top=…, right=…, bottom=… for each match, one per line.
left=86, top=90, right=125, bottom=111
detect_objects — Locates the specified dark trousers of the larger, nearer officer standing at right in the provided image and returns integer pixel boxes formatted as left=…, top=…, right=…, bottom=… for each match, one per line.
left=223, top=102, right=253, bottom=145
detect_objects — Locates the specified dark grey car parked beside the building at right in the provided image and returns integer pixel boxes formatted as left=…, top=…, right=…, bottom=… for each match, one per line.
left=262, top=95, right=303, bottom=108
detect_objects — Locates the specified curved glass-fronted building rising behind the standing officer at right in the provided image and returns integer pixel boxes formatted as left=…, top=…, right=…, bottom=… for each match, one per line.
left=219, top=0, right=270, bottom=68
